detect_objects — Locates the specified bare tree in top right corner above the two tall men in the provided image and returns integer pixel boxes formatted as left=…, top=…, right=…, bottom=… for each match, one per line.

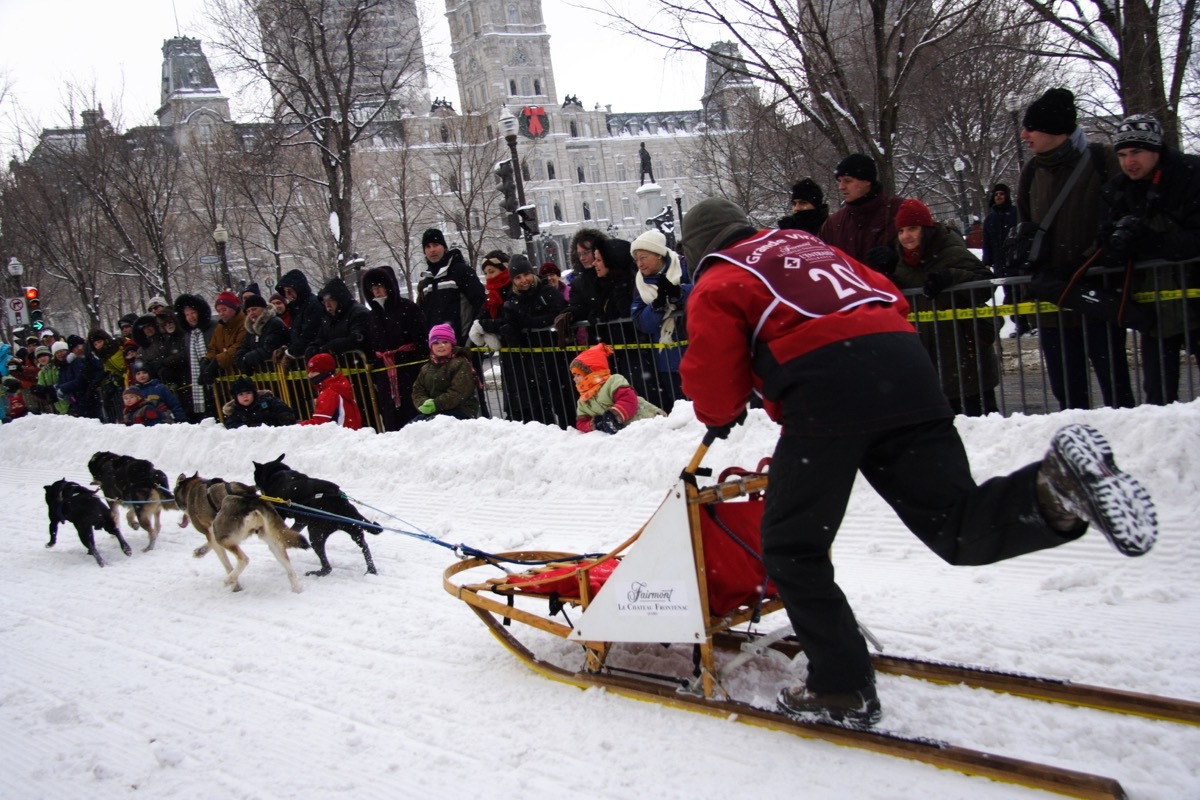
left=1022, top=0, right=1200, bottom=146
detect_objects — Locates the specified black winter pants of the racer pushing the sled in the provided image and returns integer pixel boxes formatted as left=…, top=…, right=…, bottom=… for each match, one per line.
left=762, top=419, right=1086, bottom=692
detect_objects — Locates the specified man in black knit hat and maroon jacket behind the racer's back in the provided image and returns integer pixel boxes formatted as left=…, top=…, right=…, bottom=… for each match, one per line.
left=818, top=152, right=900, bottom=263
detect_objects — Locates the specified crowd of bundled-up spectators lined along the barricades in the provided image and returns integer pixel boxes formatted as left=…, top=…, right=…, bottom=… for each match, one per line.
left=0, top=89, right=1200, bottom=431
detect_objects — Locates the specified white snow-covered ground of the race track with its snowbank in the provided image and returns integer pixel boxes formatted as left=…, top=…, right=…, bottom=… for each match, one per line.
left=0, top=403, right=1200, bottom=800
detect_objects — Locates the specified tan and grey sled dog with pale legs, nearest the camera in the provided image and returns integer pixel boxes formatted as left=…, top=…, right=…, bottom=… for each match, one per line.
left=175, top=475, right=308, bottom=591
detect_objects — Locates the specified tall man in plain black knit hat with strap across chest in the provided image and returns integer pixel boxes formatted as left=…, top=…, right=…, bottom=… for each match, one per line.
left=1016, top=89, right=1141, bottom=409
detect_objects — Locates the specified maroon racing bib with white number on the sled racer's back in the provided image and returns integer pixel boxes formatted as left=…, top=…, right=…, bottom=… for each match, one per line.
left=697, top=230, right=900, bottom=319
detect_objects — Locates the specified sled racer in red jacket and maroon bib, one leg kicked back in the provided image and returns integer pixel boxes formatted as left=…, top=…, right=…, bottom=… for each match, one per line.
left=680, top=198, right=1157, bottom=727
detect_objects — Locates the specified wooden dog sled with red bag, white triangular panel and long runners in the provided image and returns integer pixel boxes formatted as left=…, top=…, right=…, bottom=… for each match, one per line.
left=443, top=438, right=1200, bottom=798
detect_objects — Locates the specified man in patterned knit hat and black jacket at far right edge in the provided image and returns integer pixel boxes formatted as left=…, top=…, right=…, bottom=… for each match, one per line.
left=1102, top=114, right=1200, bottom=405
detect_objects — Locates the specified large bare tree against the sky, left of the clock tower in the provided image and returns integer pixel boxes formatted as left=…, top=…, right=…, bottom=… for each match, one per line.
left=209, top=0, right=427, bottom=282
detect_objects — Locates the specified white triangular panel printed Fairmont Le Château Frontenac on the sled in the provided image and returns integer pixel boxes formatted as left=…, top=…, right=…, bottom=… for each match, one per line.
left=570, top=480, right=704, bottom=643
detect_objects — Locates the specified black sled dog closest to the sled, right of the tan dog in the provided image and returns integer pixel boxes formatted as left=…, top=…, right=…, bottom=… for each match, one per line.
left=252, top=453, right=379, bottom=576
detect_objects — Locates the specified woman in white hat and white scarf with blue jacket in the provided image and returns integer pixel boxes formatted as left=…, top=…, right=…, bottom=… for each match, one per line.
left=629, top=229, right=691, bottom=414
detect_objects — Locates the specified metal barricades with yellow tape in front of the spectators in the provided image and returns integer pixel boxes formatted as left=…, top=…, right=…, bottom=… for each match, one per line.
left=214, top=260, right=1200, bottom=432
